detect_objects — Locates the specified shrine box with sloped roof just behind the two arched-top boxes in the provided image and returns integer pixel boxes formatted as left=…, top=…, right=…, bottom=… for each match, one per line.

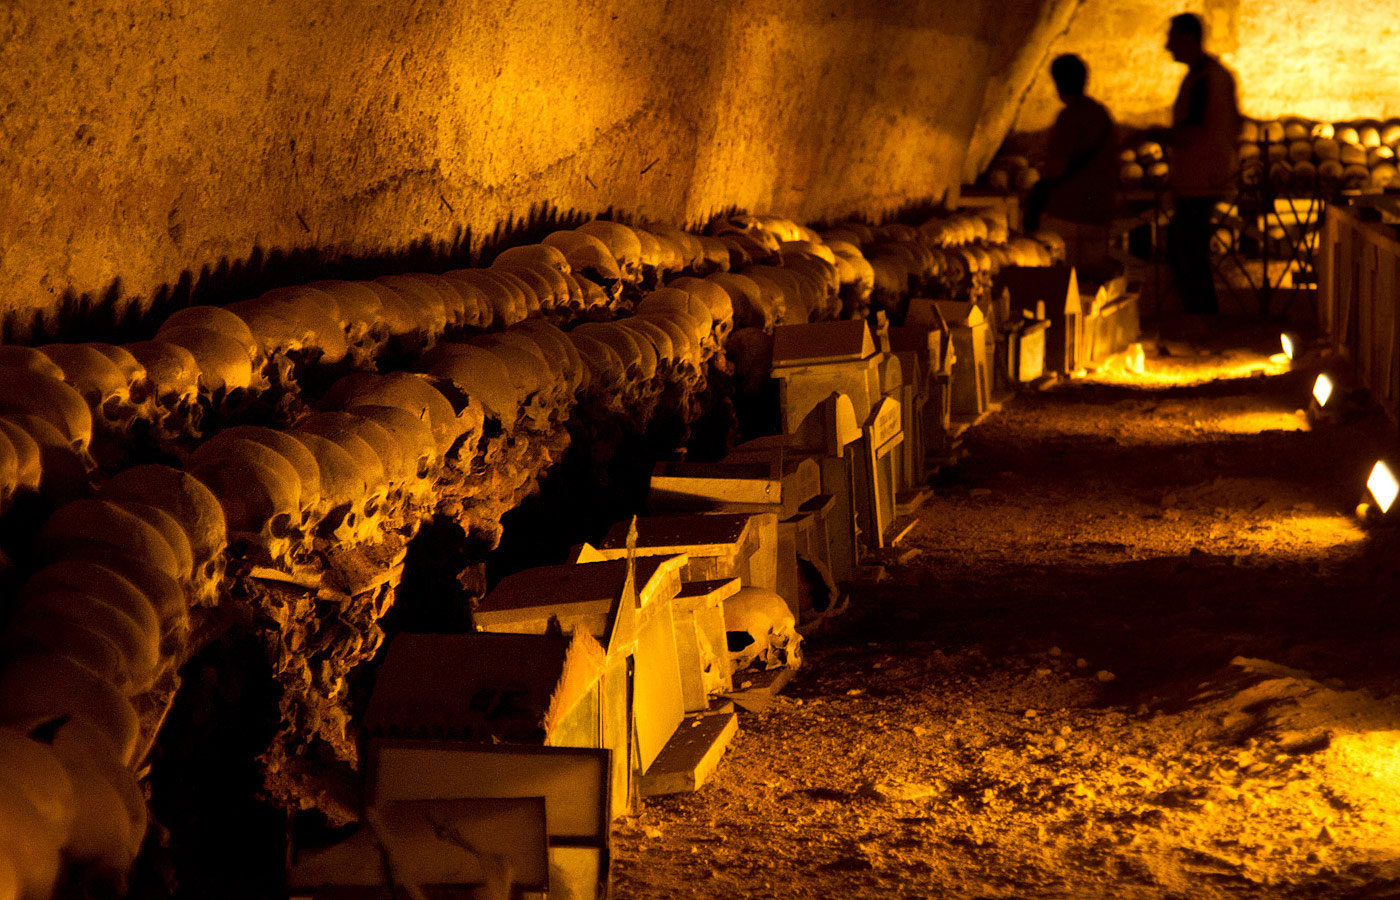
left=773, top=322, right=883, bottom=433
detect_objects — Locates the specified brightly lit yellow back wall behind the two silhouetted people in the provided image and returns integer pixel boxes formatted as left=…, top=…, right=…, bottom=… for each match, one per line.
left=1015, top=0, right=1400, bottom=132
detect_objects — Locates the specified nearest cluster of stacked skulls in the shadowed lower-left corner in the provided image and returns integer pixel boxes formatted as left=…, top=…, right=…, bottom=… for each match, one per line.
left=0, top=466, right=225, bottom=897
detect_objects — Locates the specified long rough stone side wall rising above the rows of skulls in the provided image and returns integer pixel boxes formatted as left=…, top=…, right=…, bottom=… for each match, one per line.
left=0, top=0, right=1042, bottom=340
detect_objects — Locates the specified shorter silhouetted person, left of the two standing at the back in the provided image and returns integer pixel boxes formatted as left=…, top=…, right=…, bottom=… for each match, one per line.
left=1026, top=53, right=1119, bottom=283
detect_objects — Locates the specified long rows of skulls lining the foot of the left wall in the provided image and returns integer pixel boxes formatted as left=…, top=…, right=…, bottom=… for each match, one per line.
left=0, top=209, right=1058, bottom=896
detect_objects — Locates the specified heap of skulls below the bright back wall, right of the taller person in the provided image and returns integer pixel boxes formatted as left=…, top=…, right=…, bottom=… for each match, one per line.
left=1239, top=119, right=1400, bottom=193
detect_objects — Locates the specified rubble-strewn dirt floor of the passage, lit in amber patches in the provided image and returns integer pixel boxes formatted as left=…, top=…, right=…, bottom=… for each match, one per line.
left=616, top=323, right=1400, bottom=900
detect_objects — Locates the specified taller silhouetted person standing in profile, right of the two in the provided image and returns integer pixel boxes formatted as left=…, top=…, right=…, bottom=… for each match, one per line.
left=1166, top=13, right=1240, bottom=314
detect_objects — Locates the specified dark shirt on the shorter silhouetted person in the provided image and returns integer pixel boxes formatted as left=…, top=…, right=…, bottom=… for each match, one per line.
left=1042, top=97, right=1119, bottom=225
